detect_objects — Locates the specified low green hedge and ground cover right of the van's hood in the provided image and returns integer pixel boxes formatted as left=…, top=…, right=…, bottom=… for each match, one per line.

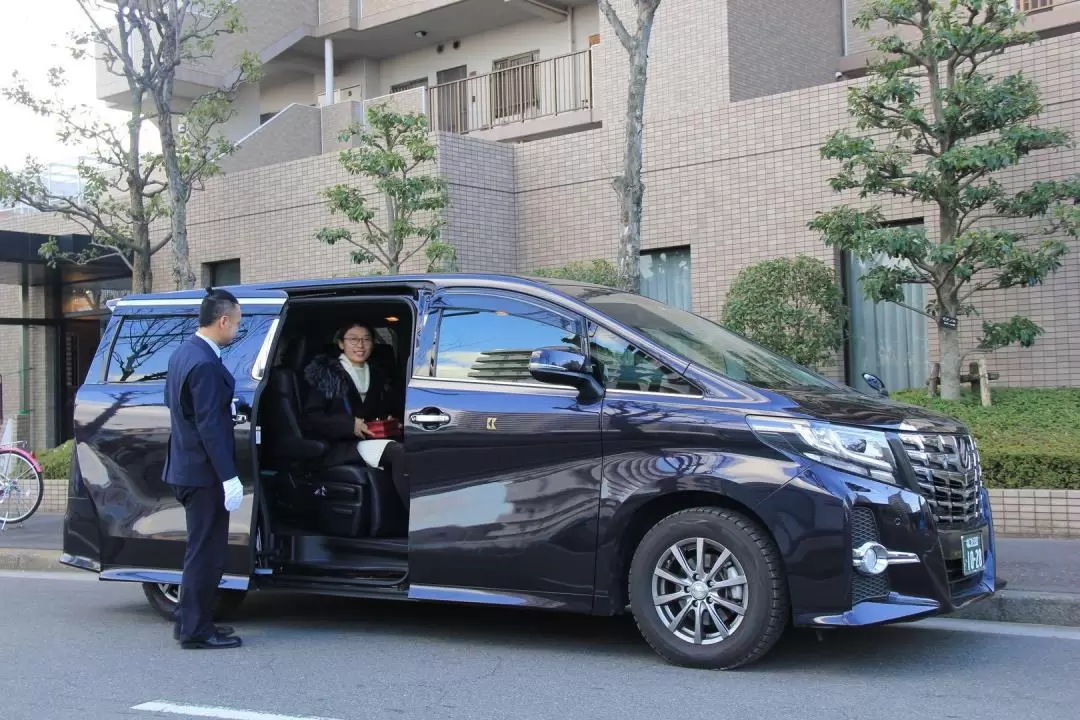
left=893, top=388, right=1080, bottom=490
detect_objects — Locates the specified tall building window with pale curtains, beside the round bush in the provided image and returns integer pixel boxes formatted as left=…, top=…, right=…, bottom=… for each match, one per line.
left=842, top=221, right=930, bottom=392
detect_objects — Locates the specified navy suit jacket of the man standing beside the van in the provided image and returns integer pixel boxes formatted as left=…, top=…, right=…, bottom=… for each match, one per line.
left=162, top=336, right=238, bottom=487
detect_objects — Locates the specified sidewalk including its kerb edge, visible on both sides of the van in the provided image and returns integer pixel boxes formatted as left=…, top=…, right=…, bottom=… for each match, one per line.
left=0, top=514, right=1080, bottom=627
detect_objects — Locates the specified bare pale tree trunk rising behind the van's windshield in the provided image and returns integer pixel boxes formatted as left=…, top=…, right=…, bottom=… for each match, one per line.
left=600, top=0, right=660, bottom=293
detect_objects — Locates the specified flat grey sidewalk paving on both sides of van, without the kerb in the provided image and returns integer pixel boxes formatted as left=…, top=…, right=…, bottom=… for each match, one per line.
left=0, top=514, right=1080, bottom=593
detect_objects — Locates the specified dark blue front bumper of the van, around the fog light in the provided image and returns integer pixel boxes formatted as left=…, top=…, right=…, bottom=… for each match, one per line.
left=793, top=481, right=997, bottom=627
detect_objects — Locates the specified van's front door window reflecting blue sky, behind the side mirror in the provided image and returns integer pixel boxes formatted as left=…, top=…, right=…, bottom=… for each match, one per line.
left=435, top=308, right=580, bottom=383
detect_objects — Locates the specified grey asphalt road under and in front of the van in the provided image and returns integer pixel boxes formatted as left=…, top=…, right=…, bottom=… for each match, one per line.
left=0, top=572, right=1080, bottom=720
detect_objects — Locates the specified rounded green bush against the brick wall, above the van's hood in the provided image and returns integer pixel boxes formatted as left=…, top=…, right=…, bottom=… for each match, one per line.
left=721, top=255, right=845, bottom=367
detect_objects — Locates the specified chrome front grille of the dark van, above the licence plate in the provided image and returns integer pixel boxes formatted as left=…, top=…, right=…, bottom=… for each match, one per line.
left=900, top=434, right=983, bottom=525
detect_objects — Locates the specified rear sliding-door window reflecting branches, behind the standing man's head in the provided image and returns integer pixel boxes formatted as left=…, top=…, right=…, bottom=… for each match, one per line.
left=108, top=315, right=273, bottom=382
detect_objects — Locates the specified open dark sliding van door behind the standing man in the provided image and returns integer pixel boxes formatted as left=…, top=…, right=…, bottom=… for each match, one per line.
left=63, top=288, right=287, bottom=590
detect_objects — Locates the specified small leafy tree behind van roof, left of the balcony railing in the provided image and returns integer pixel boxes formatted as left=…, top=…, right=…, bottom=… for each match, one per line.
left=315, top=104, right=457, bottom=275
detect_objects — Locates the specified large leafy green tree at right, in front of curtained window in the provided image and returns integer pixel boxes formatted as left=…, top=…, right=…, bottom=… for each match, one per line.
left=809, top=0, right=1080, bottom=399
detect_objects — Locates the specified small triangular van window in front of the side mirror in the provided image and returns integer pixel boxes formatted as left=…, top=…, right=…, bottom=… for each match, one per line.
left=589, top=326, right=699, bottom=395
